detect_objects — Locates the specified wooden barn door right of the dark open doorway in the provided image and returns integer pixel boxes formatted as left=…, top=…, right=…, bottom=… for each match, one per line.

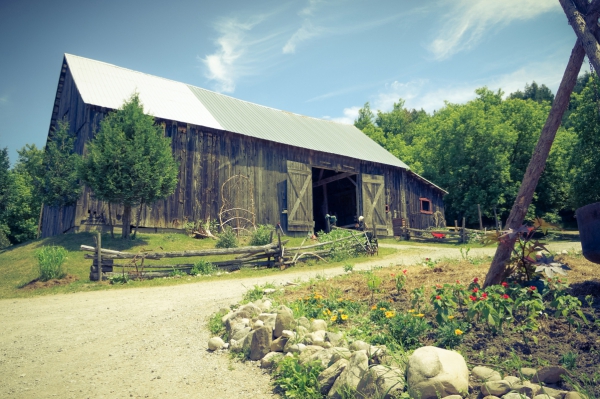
left=361, top=173, right=388, bottom=235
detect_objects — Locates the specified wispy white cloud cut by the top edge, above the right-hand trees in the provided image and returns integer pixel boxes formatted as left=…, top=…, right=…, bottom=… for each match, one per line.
left=429, top=0, right=560, bottom=60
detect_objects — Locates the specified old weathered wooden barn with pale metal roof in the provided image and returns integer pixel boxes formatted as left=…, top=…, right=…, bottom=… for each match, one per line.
left=42, top=54, right=445, bottom=237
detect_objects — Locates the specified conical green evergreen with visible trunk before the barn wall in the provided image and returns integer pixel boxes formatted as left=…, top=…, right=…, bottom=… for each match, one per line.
left=80, top=93, right=178, bottom=238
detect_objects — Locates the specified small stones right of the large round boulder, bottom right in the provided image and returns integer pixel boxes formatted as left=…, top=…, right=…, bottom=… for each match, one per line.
left=472, top=366, right=581, bottom=399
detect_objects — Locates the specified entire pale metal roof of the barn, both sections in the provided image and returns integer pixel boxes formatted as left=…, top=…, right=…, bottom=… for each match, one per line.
left=65, top=54, right=409, bottom=169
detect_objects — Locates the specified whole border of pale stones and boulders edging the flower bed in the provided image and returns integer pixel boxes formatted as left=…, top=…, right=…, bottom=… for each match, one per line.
left=208, top=298, right=579, bottom=399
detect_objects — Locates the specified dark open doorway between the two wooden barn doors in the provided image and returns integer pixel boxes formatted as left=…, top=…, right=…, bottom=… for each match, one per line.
left=312, top=168, right=358, bottom=232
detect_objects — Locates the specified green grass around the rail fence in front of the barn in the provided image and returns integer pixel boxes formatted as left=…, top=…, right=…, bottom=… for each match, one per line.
left=0, top=233, right=396, bottom=299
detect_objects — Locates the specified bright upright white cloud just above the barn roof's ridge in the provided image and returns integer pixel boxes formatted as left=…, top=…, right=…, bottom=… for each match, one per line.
left=200, top=16, right=264, bottom=93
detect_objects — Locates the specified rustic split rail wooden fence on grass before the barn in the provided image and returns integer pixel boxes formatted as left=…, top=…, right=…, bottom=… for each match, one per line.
left=80, top=233, right=373, bottom=281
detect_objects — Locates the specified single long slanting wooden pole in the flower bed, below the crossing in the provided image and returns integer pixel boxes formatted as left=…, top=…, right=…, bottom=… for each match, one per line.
left=483, top=40, right=585, bottom=288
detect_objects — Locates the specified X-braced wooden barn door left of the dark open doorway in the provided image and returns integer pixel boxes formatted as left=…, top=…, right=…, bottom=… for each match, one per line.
left=287, top=161, right=314, bottom=231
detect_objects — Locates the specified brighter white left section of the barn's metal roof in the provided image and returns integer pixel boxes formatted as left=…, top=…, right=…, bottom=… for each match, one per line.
left=65, top=54, right=222, bottom=129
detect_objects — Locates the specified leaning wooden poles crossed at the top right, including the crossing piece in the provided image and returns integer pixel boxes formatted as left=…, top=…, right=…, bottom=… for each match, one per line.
left=484, top=0, right=600, bottom=287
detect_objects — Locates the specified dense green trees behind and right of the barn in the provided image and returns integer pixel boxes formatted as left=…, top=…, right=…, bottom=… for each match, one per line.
left=354, top=73, right=600, bottom=228
